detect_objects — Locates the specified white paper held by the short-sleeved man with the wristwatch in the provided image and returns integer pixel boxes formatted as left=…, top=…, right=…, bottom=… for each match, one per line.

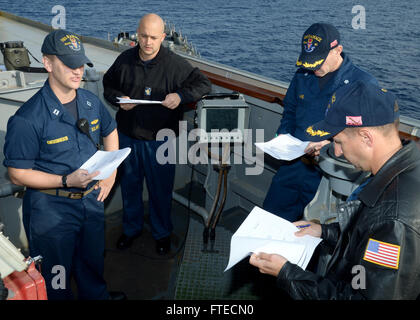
left=80, top=148, right=131, bottom=180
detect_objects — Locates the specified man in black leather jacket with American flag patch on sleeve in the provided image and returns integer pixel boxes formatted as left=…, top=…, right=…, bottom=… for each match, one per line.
left=250, top=81, right=420, bottom=300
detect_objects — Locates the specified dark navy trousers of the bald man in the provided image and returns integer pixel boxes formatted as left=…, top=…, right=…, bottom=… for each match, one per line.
left=118, top=132, right=175, bottom=239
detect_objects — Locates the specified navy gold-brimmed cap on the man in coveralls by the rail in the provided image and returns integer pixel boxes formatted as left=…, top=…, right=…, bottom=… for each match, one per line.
left=296, top=23, right=340, bottom=70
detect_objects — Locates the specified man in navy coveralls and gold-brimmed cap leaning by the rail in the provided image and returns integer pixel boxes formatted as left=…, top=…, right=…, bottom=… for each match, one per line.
left=263, top=23, right=377, bottom=222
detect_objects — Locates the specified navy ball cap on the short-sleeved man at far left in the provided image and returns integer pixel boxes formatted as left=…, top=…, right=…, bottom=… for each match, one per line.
left=41, top=29, right=93, bottom=69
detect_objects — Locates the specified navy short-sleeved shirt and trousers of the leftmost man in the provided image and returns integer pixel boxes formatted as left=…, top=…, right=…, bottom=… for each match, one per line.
left=4, top=81, right=116, bottom=299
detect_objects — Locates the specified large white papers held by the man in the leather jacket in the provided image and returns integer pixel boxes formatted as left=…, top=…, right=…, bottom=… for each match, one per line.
left=225, top=207, right=322, bottom=271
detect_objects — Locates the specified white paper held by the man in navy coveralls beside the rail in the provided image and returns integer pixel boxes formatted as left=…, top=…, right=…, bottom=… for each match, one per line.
left=255, top=134, right=309, bottom=161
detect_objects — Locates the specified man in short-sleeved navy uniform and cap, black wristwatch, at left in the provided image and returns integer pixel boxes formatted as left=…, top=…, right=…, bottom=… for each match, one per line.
left=4, top=30, right=123, bottom=300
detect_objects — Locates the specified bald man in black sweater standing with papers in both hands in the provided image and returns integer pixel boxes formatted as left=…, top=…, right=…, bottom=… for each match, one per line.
left=103, top=14, right=211, bottom=254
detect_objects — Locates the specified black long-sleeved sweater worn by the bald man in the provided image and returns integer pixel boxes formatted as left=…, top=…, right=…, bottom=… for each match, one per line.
left=103, top=46, right=211, bottom=140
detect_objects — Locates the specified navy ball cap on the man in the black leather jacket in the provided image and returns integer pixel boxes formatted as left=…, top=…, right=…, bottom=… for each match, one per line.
left=306, top=81, right=400, bottom=142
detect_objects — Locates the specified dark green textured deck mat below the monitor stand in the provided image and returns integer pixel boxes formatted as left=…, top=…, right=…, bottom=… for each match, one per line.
left=172, top=184, right=288, bottom=300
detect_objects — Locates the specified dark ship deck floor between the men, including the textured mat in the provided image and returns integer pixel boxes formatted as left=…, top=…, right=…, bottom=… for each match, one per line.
left=105, top=185, right=288, bottom=300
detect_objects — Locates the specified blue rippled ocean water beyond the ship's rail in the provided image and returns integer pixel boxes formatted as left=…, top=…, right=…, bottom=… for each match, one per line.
left=0, top=0, right=420, bottom=120
